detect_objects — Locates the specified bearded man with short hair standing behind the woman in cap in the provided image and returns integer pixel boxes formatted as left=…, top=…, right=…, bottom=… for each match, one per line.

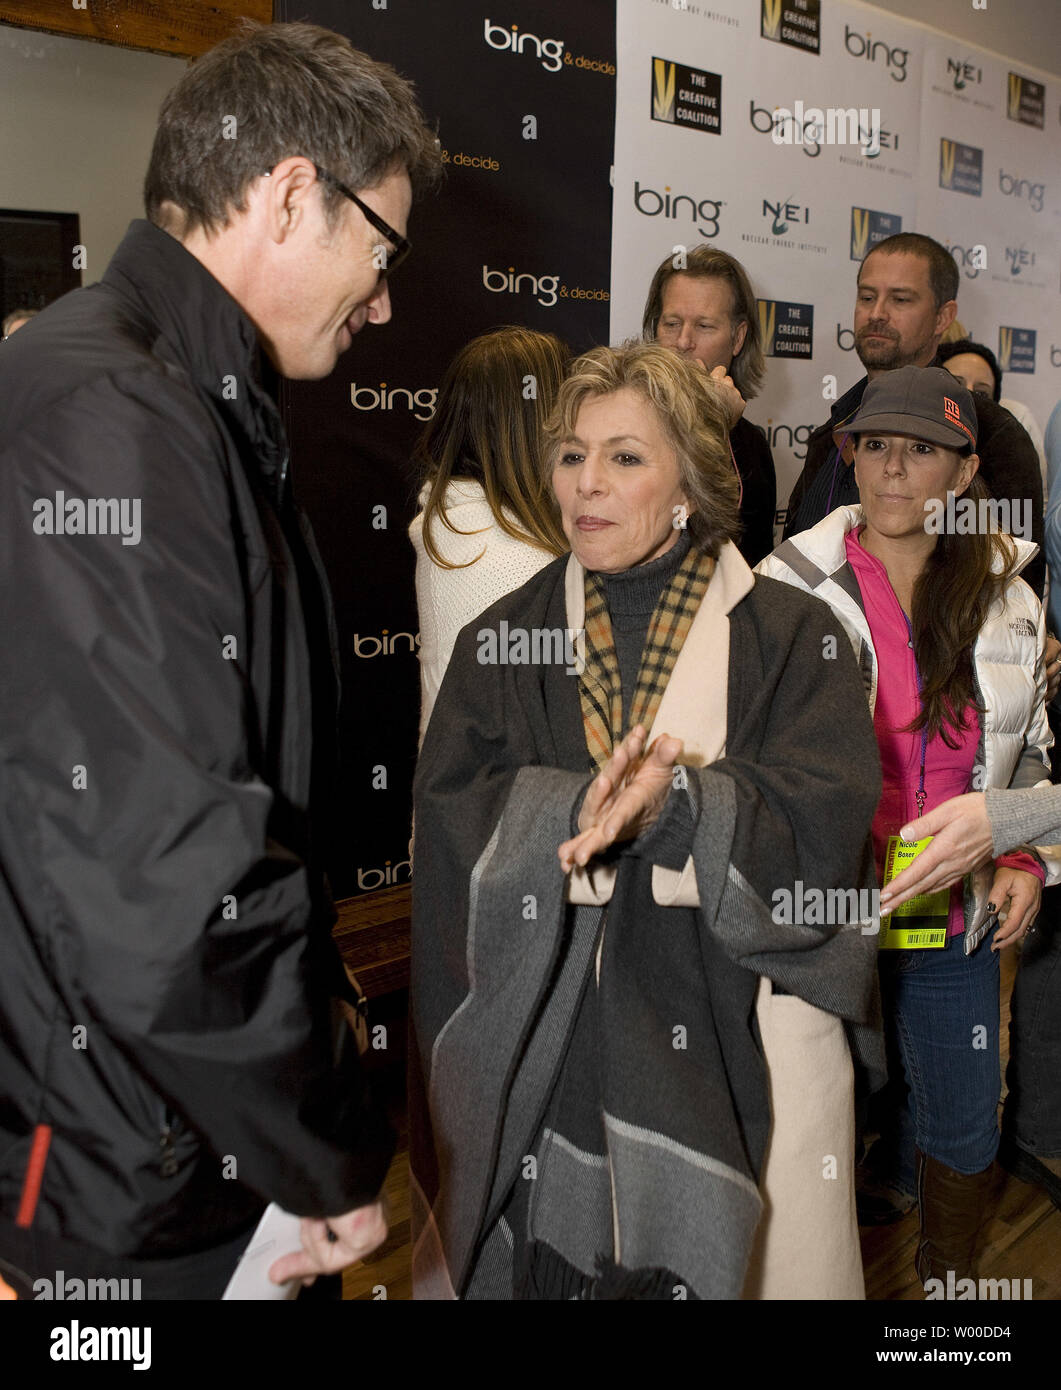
left=784, top=232, right=1046, bottom=598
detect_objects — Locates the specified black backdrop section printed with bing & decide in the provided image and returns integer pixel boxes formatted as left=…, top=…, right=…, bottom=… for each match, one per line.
left=277, top=0, right=615, bottom=897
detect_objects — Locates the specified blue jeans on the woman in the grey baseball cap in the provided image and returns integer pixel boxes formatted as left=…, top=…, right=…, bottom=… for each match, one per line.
left=879, top=933, right=1001, bottom=1193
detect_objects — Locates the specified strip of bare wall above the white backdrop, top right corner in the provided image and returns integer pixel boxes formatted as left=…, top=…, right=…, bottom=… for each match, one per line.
left=868, top=0, right=1061, bottom=74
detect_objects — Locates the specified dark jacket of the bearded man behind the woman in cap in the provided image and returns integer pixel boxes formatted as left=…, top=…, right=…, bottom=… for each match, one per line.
left=783, top=360, right=1046, bottom=599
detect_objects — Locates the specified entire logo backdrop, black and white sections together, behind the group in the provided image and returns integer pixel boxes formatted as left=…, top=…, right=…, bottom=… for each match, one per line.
left=286, top=0, right=1061, bottom=895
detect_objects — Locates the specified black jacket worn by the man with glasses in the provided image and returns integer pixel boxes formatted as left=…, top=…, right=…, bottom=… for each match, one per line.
left=0, top=221, right=392, bottom=1259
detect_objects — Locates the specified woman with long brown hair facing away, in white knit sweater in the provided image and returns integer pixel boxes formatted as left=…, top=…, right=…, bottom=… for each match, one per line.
left=409, top=328, right=569, bottom=741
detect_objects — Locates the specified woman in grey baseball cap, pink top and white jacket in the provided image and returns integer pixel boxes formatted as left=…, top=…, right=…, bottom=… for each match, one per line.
left=758, top=367, right=1061, bottom=1297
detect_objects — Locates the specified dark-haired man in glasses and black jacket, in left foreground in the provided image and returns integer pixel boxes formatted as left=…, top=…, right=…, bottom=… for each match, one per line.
left=0, top=25, right=438, bottom=1298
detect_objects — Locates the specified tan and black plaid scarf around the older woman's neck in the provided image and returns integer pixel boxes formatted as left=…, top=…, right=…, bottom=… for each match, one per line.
left=578, top=545, right=715, bottom=771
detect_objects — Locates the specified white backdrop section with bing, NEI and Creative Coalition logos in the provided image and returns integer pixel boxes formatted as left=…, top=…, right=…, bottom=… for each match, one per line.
left=612, top=0, right=1061, bottom=520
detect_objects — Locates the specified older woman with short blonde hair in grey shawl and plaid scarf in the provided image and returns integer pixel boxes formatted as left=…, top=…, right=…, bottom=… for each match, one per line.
left=410, top=343, right=883, bottom=1300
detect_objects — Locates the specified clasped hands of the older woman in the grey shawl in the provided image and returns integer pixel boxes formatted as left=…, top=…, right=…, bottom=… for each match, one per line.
left=558, top=724, right=681, bottom=873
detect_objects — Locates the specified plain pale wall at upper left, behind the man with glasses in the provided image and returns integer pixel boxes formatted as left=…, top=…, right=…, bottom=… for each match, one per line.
left=0, top=25, right=185, bottom=285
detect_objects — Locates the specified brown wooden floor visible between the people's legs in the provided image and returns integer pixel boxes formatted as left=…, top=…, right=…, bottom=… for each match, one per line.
left=343, top=951, right=1061, bottom=1300
